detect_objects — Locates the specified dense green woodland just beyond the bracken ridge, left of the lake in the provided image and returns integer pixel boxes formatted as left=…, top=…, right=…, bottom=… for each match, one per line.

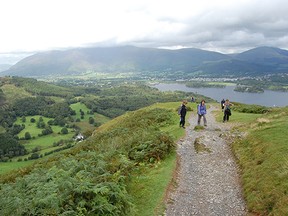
left=81, top=85, right=194, bottom=118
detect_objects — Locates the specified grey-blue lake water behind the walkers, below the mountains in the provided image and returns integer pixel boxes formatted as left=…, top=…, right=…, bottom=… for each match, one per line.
left=153, top=83, right=288, bottom=107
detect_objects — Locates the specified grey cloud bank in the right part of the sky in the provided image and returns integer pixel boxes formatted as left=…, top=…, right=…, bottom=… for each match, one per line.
left=126, top=0, right=288, bottom=51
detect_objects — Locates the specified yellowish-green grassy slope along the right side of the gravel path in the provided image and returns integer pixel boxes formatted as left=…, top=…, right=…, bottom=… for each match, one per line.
left=214, top=104, right=288, bottom=215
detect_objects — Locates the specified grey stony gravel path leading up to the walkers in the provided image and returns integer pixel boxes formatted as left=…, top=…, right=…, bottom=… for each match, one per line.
left=165, top=104, right=247, bottom=216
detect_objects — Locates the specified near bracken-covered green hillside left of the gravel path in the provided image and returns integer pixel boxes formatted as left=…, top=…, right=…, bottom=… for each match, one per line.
left=0, top=102, right=184, bottom=215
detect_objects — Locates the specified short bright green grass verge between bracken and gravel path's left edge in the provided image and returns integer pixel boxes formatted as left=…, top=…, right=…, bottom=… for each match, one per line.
left=128, top=102, right=187, bottom=216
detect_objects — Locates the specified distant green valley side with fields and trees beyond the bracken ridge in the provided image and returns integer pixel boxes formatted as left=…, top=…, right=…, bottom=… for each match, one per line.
left=0, top=77, right=196, bottom=173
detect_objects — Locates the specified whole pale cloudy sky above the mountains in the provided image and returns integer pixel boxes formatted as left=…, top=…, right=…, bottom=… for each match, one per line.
left=0, top=0, right=288, bottom=63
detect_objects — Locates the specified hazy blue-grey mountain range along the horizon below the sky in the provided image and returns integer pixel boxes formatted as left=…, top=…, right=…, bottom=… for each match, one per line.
left=0, top=46, right=288, bottom=77
